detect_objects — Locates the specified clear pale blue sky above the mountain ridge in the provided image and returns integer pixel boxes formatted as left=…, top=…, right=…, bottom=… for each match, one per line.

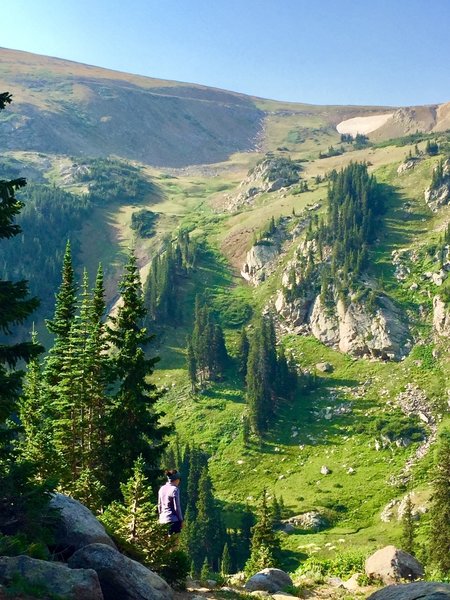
left=0, top=0, right=450, bottom=105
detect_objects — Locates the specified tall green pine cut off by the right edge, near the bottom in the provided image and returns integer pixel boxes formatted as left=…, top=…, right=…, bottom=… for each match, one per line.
left=429, top=429, right=450, bottom=575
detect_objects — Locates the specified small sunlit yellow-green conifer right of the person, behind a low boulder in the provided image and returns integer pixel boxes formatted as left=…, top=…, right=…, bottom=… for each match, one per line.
left=245, top=490, right=280, bottom=576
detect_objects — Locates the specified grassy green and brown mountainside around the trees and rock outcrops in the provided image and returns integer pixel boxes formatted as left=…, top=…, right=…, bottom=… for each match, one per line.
left=0, top=50, right=450, bottom=569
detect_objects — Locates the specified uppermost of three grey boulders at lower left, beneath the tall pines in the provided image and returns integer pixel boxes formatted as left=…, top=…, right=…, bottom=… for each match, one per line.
left=50, top=494, right=116, bottom=556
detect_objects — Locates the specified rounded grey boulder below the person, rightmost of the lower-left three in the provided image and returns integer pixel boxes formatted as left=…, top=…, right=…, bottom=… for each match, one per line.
left=69, top=544, right=173, bottom=600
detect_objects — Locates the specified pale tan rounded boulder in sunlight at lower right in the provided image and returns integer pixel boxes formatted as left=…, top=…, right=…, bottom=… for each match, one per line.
left=365, top=546, right=424, bottom=584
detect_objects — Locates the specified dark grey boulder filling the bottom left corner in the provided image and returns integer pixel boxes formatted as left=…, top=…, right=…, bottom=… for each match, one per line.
left=0, top=556, right=103, bottom=600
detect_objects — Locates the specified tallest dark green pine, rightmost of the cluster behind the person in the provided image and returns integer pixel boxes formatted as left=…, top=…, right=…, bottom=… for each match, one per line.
left=107, top=246, right=166, bottom=498
